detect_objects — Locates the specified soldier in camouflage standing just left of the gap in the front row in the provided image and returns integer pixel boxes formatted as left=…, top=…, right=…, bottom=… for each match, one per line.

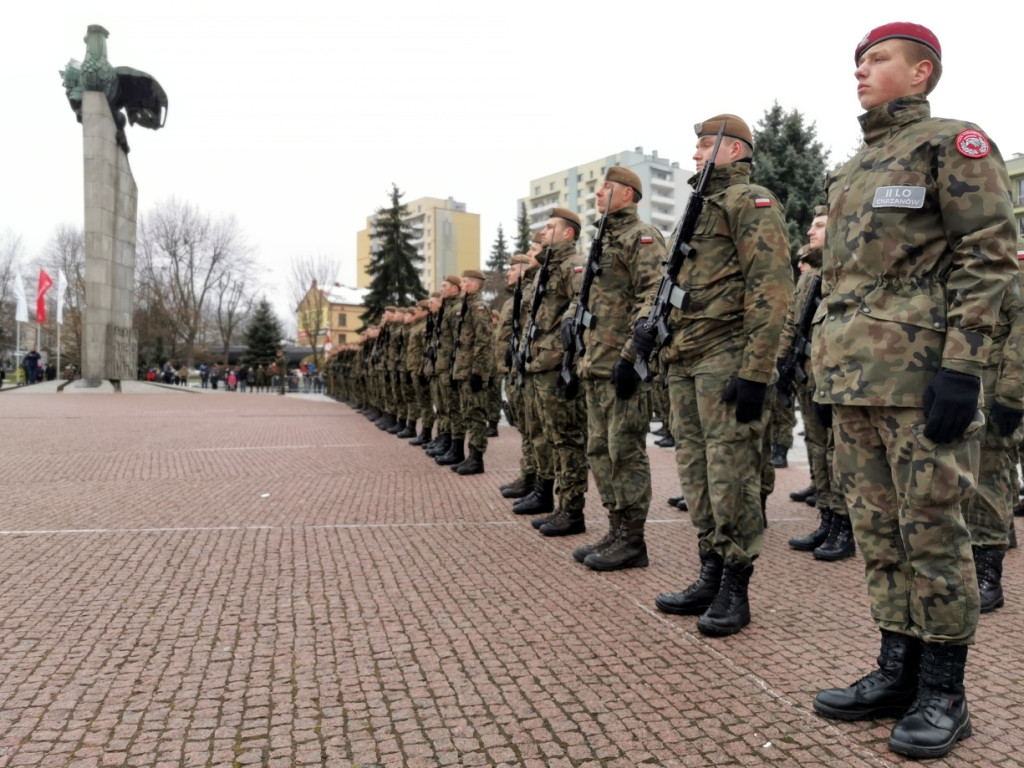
left=452, top=269, right=495, bottom=475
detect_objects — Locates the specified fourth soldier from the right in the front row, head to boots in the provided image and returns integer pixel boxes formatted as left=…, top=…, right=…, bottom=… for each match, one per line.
left=526, top=208, right=588, bottom=536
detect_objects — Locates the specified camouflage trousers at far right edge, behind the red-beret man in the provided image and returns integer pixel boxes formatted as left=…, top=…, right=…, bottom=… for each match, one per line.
left=963, top=369, right=1024, bottom=549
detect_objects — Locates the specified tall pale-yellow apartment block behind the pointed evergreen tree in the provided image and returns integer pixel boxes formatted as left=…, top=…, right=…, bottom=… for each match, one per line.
left=355, top=198, right=480, bottom=291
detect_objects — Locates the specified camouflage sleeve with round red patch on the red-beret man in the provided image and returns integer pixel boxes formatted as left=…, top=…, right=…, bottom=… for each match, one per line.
left=932, top=129, right=1017, bottom=376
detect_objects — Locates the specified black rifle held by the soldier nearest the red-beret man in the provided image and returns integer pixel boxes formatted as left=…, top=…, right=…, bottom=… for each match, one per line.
left=633, top=120, right=726, bottom=381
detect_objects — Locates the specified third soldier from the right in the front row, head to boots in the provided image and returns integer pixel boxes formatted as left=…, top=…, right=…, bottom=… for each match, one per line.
left=563, top=166, right=667, bottom=570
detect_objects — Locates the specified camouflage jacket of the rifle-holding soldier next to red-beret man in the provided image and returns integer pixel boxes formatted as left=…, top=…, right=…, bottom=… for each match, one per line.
left=647, top=161, right=794, bottom=383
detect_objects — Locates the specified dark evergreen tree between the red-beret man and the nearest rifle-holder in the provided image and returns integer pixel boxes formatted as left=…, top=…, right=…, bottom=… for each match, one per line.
left=751, top=101, right=828, bottom=260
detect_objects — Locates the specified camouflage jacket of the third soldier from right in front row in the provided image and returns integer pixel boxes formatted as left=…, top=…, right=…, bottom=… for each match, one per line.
left=565, top=205, right=668, bottom=379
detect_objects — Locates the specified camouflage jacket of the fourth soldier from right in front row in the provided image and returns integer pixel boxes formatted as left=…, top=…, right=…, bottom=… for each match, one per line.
left=526, top=243, right=593, bottom=374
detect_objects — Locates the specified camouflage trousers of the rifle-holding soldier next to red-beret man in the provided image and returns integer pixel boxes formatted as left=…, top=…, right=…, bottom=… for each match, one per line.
left=669, top=350, right=774, bottom=568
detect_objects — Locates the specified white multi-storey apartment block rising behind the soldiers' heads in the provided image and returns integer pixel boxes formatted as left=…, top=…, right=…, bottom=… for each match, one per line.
left=519, top=146, right=693, bottom=253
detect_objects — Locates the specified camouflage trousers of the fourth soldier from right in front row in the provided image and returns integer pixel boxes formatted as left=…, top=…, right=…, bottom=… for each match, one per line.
left=530, top=371, right=588, bottom=512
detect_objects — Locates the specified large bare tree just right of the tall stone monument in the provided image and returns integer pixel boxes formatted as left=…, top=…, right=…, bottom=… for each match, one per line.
left=138, top=198, right=250, bottom=368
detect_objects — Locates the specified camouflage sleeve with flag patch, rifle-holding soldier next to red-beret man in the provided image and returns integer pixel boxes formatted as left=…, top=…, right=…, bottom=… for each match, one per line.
left=729, top=186, right=794, bottom=382
